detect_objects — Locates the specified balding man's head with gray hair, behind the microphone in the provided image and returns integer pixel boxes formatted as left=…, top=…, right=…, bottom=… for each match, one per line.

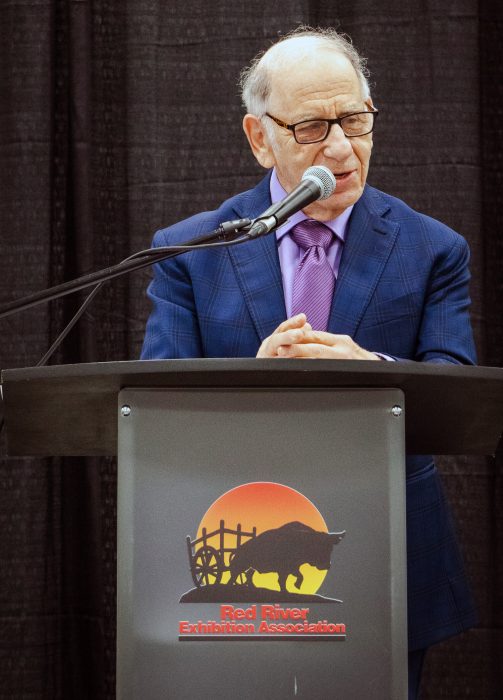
left=241, top=29, right=373, bottom=221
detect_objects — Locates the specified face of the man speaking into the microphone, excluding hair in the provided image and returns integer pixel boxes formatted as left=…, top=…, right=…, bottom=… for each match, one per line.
left=244, top=49, right=372, bottom=221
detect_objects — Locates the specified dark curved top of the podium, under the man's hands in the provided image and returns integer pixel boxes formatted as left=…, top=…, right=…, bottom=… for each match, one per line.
left=2, top=358, right=503, bottom=456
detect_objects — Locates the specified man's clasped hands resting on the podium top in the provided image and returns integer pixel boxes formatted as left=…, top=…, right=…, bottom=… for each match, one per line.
left=257, top=314, right=380, bottom=360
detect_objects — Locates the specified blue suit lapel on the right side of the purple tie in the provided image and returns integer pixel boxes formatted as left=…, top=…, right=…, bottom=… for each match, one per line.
left=328, top=186, right=400, bottom=337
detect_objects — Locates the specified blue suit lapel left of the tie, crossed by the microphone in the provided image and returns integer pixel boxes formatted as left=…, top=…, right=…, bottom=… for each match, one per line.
left=227, top=176, right=286, bottom=339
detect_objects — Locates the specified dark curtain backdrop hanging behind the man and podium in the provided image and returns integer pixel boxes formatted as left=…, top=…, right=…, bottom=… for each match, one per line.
left=0, top=0, right=503, bottom=700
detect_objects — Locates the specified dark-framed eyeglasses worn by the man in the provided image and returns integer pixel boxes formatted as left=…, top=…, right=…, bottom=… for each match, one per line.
left=266, top=109, right=379, bottom=143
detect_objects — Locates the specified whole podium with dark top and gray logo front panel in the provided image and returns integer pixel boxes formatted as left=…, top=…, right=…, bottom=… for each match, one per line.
left=2, top=359, right=503, bottom=700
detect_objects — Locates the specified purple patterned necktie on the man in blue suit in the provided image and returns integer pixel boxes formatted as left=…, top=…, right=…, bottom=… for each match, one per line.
left=291, top=219, right=335, bottom=331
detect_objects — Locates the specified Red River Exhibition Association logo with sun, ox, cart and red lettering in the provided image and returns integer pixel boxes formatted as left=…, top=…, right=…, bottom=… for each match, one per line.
left=178, top=482, right=346, bottom=641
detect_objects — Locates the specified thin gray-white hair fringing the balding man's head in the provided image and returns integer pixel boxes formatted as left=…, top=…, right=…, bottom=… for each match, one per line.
left=238, top=26, right=370, bottom=117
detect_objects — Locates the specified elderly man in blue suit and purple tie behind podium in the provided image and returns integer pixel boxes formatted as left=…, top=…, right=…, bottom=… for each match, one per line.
left=142, top=29, right=475, bottom=697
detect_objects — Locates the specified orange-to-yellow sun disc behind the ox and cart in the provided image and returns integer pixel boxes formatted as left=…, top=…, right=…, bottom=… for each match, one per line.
left=195, top=481, right=328, bottom=594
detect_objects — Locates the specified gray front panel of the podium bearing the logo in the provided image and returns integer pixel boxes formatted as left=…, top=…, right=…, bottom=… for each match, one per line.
left=117, top=388, right=407, bottom=700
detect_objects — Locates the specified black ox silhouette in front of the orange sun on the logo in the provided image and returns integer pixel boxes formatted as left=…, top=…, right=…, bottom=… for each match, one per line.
left=229, top=521, right=346, bottom=593
